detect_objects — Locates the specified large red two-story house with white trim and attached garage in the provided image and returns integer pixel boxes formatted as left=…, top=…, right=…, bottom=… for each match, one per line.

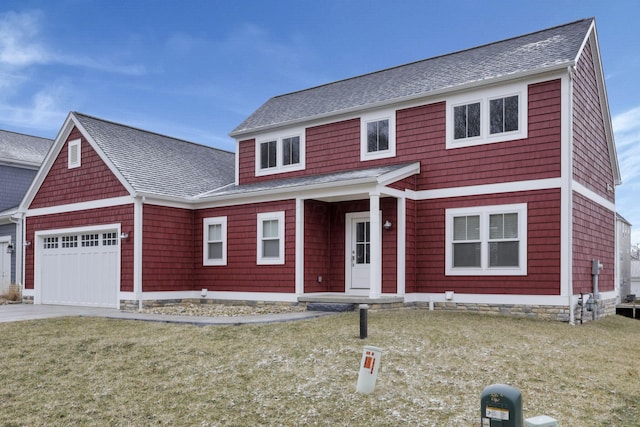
left=22, top=19, right=620, bottom=321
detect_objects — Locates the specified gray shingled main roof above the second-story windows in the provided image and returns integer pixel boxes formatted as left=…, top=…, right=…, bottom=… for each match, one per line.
left=231, top=18, right=594, bottom=136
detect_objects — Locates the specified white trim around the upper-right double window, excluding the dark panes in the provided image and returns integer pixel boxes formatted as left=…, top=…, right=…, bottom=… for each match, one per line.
left=446, top=83, right=529, bottom=149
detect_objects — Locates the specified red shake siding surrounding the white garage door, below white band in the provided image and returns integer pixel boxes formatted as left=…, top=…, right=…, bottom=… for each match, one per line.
left=25, top=204, right=134, bottom=292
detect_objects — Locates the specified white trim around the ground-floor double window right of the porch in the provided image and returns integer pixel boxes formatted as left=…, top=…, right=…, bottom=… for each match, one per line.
left=445, top=203, right=528, bottom=276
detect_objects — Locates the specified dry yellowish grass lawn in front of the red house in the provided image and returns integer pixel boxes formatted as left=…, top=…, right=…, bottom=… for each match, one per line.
left=0, top=310, right=640, bottom=427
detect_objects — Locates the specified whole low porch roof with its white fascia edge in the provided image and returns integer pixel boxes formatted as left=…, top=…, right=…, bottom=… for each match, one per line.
left=196, top=162, right=420, bottom=200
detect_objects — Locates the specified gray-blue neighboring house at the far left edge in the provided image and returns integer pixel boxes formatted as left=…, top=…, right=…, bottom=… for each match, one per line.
left=0, top=130, right=53, bottom=295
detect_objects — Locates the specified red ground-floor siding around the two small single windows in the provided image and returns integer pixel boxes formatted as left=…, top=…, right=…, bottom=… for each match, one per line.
left=194, top=200, right=296, bottom=293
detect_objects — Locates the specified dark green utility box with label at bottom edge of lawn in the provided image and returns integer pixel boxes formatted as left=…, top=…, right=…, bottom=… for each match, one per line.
left=480, top=384, right=524, bottom=427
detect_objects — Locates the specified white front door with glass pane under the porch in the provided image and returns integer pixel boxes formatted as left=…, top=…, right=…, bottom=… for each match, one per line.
left=345, top=212, right=371, bottom=293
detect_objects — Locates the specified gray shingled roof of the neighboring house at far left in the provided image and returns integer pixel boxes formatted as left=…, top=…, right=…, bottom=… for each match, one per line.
left=0, top=130, right=53, bottom=167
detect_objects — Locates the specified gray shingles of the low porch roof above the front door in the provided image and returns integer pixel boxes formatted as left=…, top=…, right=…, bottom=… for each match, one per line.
left=199, top=162, right=416, bottom=199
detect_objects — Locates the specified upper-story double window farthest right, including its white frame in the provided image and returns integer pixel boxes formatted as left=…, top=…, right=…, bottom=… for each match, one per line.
left=446, top=84, right=528, bottom=149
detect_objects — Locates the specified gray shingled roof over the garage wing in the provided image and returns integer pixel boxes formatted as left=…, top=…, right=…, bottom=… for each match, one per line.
left=71, top=112, right=235, bottom=199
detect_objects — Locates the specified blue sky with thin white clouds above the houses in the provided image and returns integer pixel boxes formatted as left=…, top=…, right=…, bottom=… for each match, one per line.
left=0, top=0, right=640, bottom=244
